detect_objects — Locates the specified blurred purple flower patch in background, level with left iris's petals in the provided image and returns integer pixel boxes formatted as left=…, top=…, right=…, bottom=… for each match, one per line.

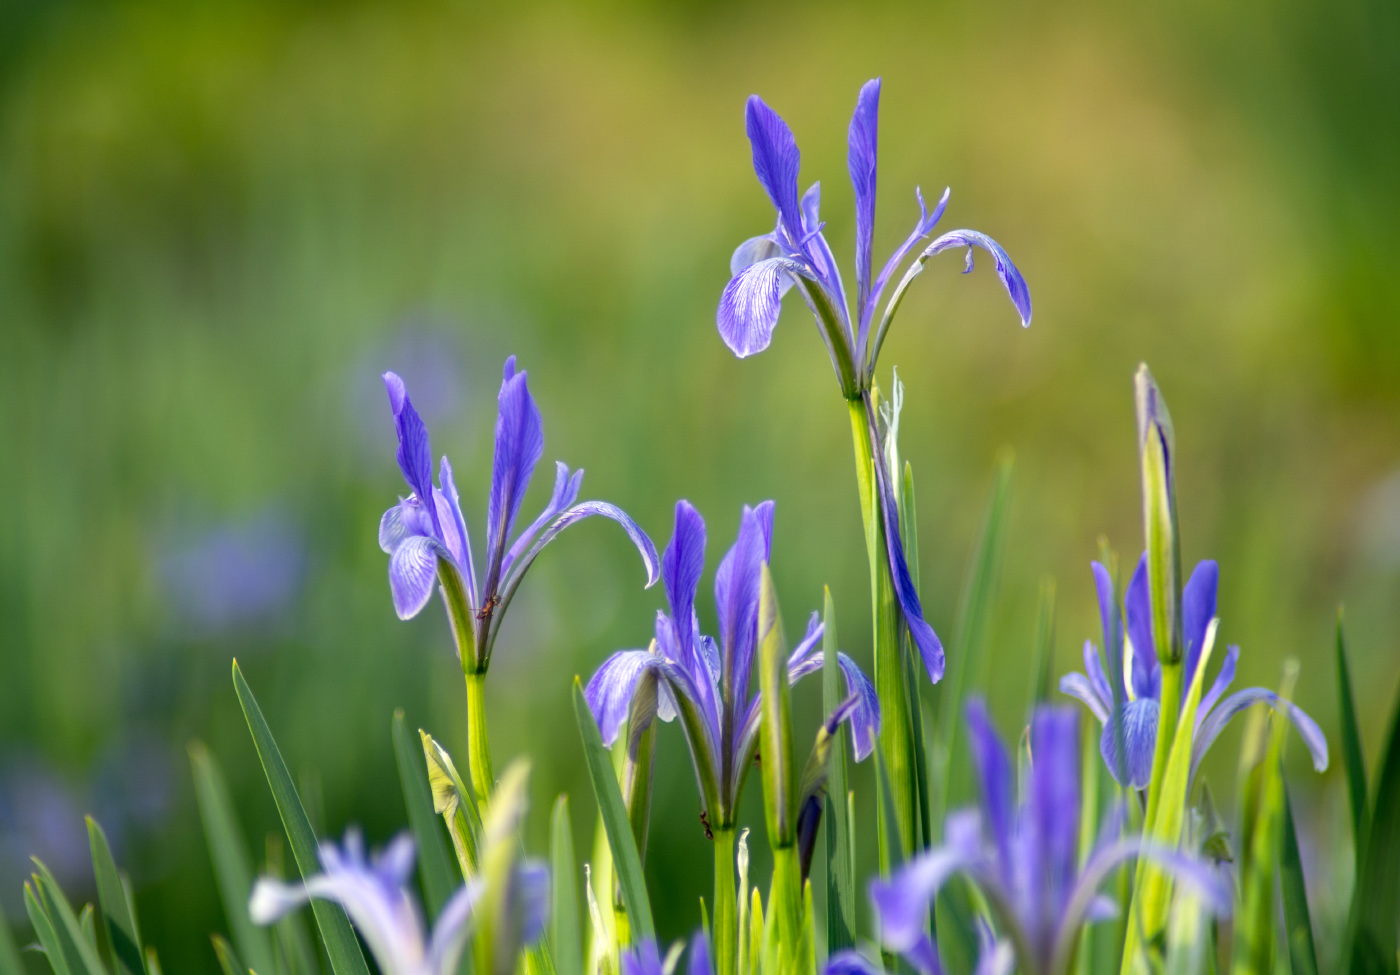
left=157, top=509, right=307, bottom=633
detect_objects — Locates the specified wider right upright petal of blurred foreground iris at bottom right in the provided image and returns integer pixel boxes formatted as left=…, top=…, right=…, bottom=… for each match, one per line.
left=1030, top=706, right=1079, bottom=948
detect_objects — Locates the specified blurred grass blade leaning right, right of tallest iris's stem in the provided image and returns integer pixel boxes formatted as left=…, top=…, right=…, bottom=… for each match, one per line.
left=932, top=450, right=1015, bottom=831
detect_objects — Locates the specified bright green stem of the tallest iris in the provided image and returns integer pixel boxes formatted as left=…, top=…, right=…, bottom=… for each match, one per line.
left=847, top=399, right=918, bottom=873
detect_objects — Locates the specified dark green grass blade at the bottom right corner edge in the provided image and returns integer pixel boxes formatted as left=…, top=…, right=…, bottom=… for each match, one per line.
left=1347, top=666, right=1400, bottom=975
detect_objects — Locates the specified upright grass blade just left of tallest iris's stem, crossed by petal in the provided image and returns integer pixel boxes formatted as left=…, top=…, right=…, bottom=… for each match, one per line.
left=817, top=588, right=855, bottom=954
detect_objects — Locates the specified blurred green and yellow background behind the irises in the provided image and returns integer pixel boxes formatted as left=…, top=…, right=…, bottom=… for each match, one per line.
left=0, top=0, right=1400, bottom=971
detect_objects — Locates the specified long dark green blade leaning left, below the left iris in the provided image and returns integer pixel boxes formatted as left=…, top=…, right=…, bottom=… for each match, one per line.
left=233, top=660, right=370, bottom=975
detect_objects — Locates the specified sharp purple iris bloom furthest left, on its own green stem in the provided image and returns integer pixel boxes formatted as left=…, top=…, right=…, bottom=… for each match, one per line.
left=379, top=356, right=659, bottom=672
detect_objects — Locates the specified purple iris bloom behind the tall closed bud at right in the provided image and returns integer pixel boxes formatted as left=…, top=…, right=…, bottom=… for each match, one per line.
left=1060, top=555, right=1327, bottom=789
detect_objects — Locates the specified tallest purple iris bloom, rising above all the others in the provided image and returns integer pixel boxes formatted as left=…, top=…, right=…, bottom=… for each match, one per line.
left=717, top=78, right=1030, bottom=399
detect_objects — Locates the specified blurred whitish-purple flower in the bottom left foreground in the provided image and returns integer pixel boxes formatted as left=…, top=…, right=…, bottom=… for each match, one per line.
left=248, top=831, right=482, bottom=975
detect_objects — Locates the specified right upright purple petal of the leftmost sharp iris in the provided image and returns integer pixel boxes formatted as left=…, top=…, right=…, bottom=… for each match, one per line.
left=486, top=356, right=545, bottom=574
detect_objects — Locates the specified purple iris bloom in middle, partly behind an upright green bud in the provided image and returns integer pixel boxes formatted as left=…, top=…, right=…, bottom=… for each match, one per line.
left=584, top=502, right=879, bottom=829
